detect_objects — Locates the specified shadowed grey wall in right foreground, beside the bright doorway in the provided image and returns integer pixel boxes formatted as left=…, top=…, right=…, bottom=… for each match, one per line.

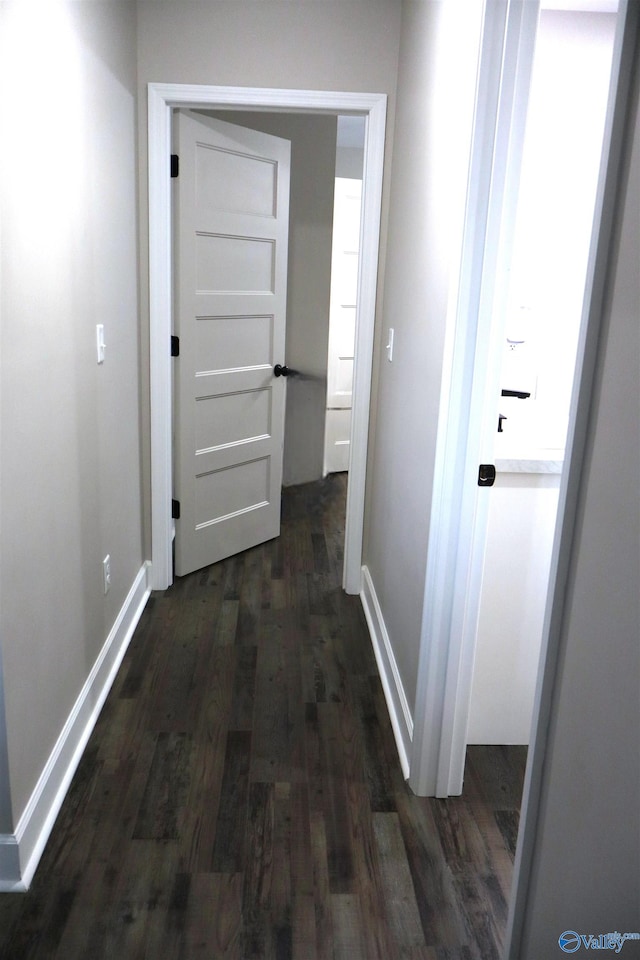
left=509, top=44, right=640, bottom=960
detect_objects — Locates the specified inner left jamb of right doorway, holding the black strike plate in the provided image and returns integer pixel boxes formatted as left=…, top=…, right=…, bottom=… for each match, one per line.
left=436, top=0, right=539, bottom=797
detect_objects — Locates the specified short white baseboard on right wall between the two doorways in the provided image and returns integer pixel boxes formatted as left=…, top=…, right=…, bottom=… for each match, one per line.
left=360, top=566, right=413, bottom=779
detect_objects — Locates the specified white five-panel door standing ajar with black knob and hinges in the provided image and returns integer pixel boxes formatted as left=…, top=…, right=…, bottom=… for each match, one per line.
left=174, top=111, right=290, bottom=576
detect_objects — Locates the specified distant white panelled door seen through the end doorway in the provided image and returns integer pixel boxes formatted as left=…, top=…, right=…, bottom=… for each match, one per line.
left=324, top=177, right=362, bottom=475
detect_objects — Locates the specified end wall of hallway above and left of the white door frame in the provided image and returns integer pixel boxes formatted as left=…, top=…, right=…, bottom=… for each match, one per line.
left=137, top=0, right=401, bottom=551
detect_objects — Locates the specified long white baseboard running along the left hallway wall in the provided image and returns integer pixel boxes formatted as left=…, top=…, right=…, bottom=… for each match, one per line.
left=0, top=562, right=151, bottom=892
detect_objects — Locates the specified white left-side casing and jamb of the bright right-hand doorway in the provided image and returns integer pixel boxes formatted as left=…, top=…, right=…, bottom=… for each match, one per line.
left=410, top=0, right=538, bottom=797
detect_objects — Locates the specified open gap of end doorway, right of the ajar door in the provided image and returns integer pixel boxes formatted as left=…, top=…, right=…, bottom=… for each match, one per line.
left=196, top=110, right=365, bottom=487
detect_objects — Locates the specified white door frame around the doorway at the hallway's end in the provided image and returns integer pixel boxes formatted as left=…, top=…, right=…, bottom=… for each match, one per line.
left=148, top=83, right=387, bottom=594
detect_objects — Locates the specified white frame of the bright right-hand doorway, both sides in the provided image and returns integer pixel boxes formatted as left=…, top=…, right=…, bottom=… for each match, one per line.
left=410, top=0, right=638, bottom=817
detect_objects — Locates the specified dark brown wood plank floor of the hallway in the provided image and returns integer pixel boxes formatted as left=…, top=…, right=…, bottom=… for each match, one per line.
left=0, top=476, right=525, bottom=960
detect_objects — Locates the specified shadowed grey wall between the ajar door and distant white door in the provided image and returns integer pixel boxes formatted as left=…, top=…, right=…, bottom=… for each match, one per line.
left=205, top=112, right=337, bottom=486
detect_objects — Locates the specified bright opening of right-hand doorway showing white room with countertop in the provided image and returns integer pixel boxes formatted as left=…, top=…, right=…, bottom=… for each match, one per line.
left=467, top=0, right=616, bottom=745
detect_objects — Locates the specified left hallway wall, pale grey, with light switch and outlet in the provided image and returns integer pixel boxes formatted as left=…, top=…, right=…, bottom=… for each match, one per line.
left=0, top=2, right=143, bottom=831
